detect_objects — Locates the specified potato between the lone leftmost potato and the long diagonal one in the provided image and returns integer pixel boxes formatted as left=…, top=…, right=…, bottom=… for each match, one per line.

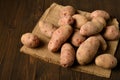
left=39, top=21, right=57, bottom=38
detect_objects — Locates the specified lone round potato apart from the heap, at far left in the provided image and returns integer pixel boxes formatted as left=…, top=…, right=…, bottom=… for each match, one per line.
left=21, top=33, right=40, bottom=48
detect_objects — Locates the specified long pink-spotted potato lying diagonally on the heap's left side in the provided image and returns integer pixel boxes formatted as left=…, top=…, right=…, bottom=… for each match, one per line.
left=48, top=25, right=73, bottom=52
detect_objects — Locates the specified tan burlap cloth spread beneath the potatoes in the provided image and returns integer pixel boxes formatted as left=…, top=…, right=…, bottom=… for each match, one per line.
left=20, top=3, right=118, bottom=78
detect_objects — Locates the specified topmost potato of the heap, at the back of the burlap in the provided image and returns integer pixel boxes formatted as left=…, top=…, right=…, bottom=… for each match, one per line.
left=60, top=5, right=76, bottom=17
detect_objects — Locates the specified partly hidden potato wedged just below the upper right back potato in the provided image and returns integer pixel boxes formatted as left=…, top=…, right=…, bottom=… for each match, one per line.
left=92, top=17, right=106, bottom=27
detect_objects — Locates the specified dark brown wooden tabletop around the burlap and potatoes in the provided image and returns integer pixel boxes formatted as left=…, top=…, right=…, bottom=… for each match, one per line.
left=0, top=0, right=120, bottom=80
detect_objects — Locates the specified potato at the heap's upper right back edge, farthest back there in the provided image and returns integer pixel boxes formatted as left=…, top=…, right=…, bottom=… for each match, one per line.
left=91, top=10, right=110, bottom=20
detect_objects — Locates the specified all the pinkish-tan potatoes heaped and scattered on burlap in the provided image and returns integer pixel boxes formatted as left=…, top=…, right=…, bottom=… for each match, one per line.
left=21, top=6, right=120, bottom=69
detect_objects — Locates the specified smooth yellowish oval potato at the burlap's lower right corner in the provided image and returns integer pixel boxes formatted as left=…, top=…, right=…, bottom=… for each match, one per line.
left=95, top=53, right=117, bottom=69
